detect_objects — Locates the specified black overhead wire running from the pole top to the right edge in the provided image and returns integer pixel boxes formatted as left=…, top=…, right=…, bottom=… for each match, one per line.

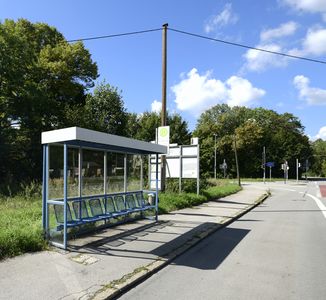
left=168, top=28, right=326, bottom=64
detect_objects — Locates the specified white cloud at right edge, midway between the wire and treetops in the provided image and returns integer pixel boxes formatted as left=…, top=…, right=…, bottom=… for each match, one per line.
left=293, top=75, right=326, bottom=105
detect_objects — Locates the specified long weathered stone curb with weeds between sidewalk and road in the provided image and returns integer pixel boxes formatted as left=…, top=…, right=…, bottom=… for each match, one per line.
left=91, top=193, right=270, bottom=300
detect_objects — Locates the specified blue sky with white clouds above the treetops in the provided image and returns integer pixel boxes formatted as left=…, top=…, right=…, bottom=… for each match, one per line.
left=0, top=0, right=326, bottom=140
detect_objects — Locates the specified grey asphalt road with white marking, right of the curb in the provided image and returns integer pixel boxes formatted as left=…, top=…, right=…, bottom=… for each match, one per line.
left=121, top=183, right=326, bottom=300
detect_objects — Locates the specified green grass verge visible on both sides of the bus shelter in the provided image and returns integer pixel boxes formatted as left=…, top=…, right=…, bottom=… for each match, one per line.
left=0, top=180, right=240, bottom=260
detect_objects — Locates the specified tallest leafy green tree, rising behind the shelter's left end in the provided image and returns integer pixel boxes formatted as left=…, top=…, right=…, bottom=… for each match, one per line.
left=0, top=19, right=97, bottom=185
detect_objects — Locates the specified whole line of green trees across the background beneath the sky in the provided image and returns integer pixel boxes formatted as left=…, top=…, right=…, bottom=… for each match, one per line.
left=0, top=19, right=320, bottom=192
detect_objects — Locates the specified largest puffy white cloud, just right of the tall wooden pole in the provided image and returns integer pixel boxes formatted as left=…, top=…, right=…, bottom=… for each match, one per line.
left=171, top=68, right=265, bottom=116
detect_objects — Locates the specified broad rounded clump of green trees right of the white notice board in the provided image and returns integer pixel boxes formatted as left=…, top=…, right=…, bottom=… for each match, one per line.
left=194, top=104, right=312, bottom=178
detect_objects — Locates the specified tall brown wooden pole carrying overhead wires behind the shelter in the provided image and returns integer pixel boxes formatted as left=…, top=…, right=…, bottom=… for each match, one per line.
left=161, top=23, right=169, bottom=191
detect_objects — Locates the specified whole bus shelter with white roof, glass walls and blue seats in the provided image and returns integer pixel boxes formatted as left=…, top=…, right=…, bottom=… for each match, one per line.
left=41, top=127, right=167, bottom=249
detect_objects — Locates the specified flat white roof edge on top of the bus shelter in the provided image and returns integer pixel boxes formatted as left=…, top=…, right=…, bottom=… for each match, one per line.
left=41, top=127, right=167, bottom=154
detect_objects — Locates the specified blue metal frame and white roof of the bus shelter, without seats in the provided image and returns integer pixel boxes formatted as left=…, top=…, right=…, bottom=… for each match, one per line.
left=41, top=127, right=167, bottom=249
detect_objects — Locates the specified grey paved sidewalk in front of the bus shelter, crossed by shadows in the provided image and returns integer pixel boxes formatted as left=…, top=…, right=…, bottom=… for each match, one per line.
left=0, top=185, right=266, bottom=300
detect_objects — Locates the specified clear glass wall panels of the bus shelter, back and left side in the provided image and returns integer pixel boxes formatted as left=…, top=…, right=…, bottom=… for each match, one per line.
left=46, top=144, right=149, bottom=245
